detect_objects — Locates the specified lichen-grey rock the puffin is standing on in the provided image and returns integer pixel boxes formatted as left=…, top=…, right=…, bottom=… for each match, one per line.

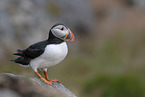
left=0, top=73, right=76, bottom=97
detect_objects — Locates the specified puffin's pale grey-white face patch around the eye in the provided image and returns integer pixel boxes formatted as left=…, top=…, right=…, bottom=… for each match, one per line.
left=51, top=25, right=69, bottom=39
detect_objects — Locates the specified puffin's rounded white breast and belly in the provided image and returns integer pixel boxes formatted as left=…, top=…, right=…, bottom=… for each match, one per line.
left=30, top=42, right=68, bottom=71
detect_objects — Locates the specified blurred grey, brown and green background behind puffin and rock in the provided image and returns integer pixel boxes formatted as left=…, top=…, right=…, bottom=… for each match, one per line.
left=0, top=0, right=145, bottom=97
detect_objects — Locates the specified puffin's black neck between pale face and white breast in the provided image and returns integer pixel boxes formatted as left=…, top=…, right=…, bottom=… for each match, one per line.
left=47, top=30, right=64, bottom=44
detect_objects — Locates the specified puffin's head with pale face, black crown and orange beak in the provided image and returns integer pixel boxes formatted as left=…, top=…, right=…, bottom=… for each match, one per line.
left=51, top=24, right=75, bottom=41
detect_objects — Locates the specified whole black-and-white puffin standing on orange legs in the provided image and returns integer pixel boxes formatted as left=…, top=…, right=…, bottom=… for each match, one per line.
left=11, top=24, right=75, bottom=85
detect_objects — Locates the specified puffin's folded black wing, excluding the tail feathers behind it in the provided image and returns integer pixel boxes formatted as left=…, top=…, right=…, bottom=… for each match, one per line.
left=23, top=40, right=48, bottom=59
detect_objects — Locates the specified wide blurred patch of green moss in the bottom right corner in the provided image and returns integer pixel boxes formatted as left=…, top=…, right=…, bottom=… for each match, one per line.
left=84, top=75, right=145, bottom=97
